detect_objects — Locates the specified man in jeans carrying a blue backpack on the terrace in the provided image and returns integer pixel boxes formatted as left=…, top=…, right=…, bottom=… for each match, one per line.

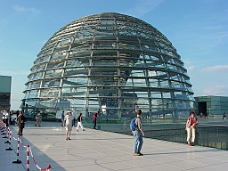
left=132, top=110, right=145, bottom=156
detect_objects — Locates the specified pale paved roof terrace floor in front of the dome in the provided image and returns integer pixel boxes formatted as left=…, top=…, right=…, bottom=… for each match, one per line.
left=0, top=121, right=228, bottom=171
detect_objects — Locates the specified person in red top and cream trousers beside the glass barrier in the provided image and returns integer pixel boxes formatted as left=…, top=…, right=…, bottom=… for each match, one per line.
left=185, top=111, right=198, bottom=146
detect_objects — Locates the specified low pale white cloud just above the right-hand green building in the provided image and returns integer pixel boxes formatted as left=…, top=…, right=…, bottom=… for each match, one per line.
left=203, top=85, right=228, bottom=96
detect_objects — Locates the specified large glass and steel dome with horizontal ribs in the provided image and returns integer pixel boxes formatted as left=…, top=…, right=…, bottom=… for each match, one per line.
left=22, top=13, right=194, bottom=117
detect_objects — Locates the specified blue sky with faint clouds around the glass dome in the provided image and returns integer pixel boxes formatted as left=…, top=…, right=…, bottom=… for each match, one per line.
left=0, top=0, right=228, bottom=110
